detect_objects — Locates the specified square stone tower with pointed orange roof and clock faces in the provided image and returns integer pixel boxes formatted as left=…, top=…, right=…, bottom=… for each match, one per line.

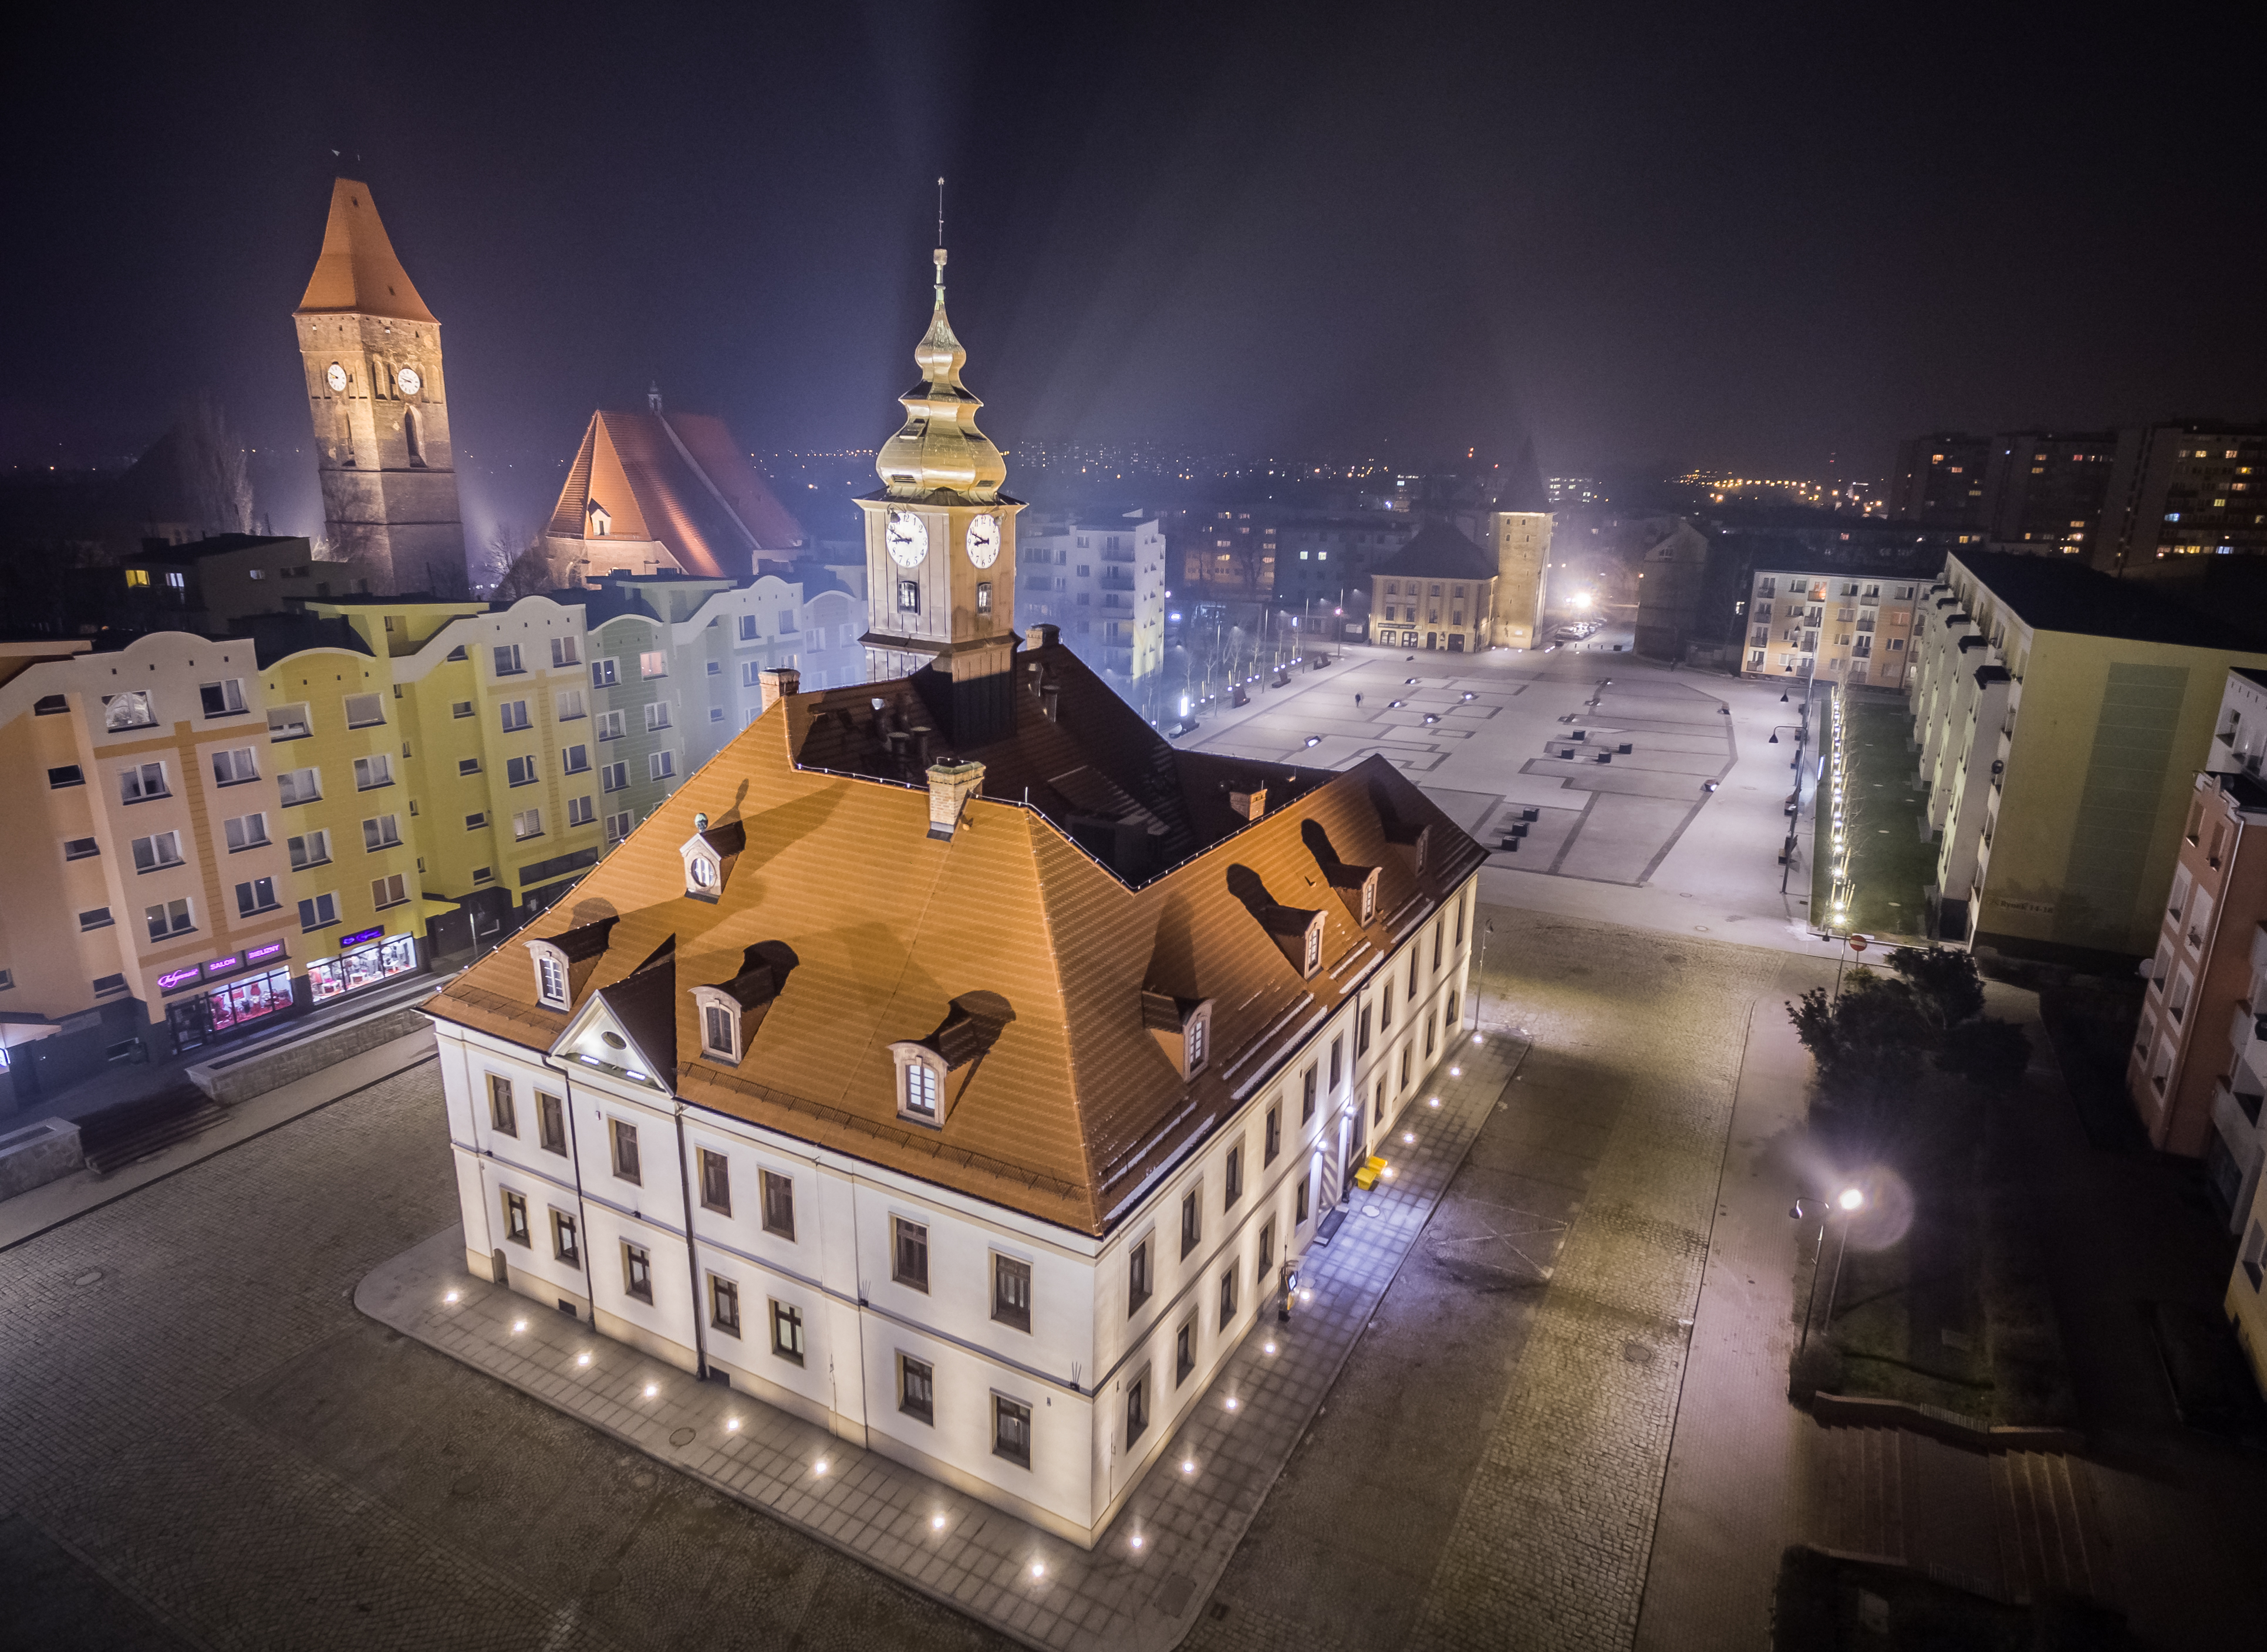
left=292, top=177, right=465, bottom=594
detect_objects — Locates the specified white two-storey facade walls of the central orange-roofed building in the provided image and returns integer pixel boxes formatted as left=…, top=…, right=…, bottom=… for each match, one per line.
left=436, top=879, right=1476, bottom=1546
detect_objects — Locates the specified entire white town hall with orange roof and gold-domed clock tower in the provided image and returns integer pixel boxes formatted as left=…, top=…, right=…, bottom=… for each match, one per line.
left=429, top=238, right=1485, bottom=1546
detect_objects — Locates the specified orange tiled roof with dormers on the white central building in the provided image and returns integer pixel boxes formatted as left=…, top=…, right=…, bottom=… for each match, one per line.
left=429, top=646, right=1485, bottom=1235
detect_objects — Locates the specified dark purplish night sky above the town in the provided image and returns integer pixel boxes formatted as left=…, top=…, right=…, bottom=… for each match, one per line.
left=0, top=5, right=2267, bottom=537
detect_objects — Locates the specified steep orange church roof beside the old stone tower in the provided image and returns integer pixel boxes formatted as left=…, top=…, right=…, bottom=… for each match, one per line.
left=549, top=410, right=802, bottom=578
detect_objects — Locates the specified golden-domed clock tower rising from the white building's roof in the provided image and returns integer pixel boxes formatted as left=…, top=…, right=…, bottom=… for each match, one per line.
left=857, top=247, right=1023, bottom=750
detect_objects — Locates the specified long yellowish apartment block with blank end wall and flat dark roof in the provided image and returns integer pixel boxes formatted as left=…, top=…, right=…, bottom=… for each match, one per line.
left=1907, top=550, right=2267, bottom=968
